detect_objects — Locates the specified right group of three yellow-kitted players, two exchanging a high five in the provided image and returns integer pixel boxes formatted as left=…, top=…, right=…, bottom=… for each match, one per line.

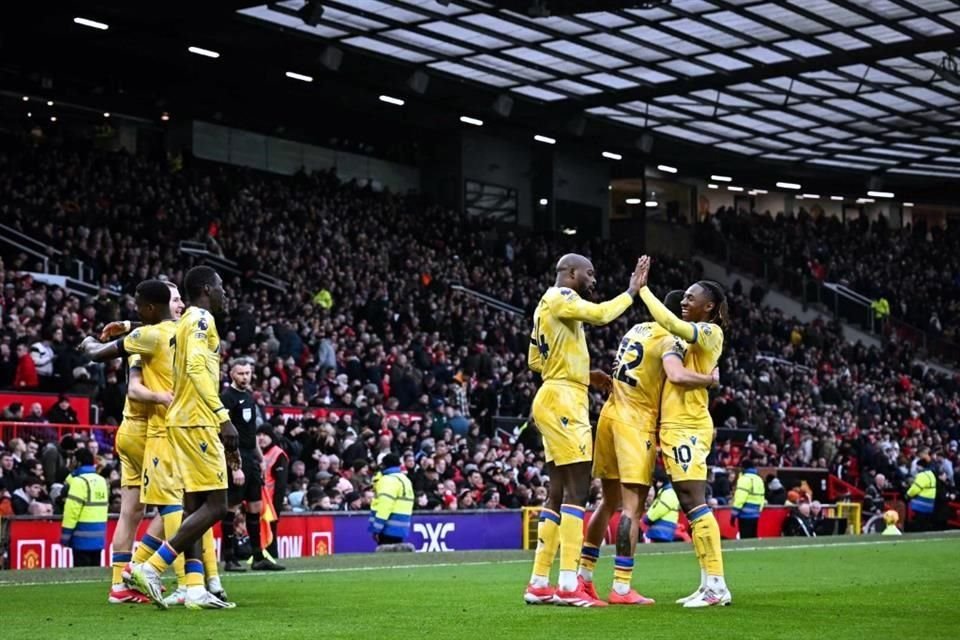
left=524, top=254, right=731, bottom=608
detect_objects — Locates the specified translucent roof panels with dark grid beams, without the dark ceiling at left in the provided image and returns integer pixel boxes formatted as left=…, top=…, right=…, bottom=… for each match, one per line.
left=240, top=0, right=960, bottom=178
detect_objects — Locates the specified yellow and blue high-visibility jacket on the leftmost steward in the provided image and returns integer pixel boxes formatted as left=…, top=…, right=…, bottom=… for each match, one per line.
left=60, top=465, right=110, bottom=551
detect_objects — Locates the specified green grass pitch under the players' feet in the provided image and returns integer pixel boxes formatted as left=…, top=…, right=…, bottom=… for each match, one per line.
left=0, top=534, right=960, bottom=640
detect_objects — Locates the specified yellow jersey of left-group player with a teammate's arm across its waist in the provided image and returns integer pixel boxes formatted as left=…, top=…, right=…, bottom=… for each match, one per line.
left=123, top=320, right=177, bottom=438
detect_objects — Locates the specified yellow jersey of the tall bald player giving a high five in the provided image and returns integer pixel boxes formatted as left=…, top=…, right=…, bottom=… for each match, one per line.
left=527, top=287, right=633, bottom=387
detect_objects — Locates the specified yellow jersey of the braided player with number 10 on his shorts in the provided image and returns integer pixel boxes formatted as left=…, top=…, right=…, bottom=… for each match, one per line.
left=660, top=322, right=723, bottom=429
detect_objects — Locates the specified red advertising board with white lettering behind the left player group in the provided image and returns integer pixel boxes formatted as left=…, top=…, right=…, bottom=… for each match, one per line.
left=8, top=514, right=334, bottom=569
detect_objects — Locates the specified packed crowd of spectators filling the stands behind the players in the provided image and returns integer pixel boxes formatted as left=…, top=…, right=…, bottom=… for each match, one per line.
left=0, top=144, right=960, bottom=524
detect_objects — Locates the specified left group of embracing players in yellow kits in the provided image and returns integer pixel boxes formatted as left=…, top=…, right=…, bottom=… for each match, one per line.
left=81, top=266, right=246, bottom=609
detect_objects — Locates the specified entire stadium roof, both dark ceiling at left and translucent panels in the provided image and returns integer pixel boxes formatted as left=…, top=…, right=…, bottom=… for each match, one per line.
left=0, top=0, right=960, bottom=196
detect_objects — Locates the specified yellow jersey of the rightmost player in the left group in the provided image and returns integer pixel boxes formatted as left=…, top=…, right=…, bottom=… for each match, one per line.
left=167, top=307, right=229, bottom=427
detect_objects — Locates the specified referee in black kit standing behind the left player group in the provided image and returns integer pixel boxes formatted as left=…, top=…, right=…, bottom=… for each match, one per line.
left=220, top=358, right=285, bottom=571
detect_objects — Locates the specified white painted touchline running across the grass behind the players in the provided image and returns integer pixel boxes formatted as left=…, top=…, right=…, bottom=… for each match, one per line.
left=0, top=536, right=960, bottom=588
